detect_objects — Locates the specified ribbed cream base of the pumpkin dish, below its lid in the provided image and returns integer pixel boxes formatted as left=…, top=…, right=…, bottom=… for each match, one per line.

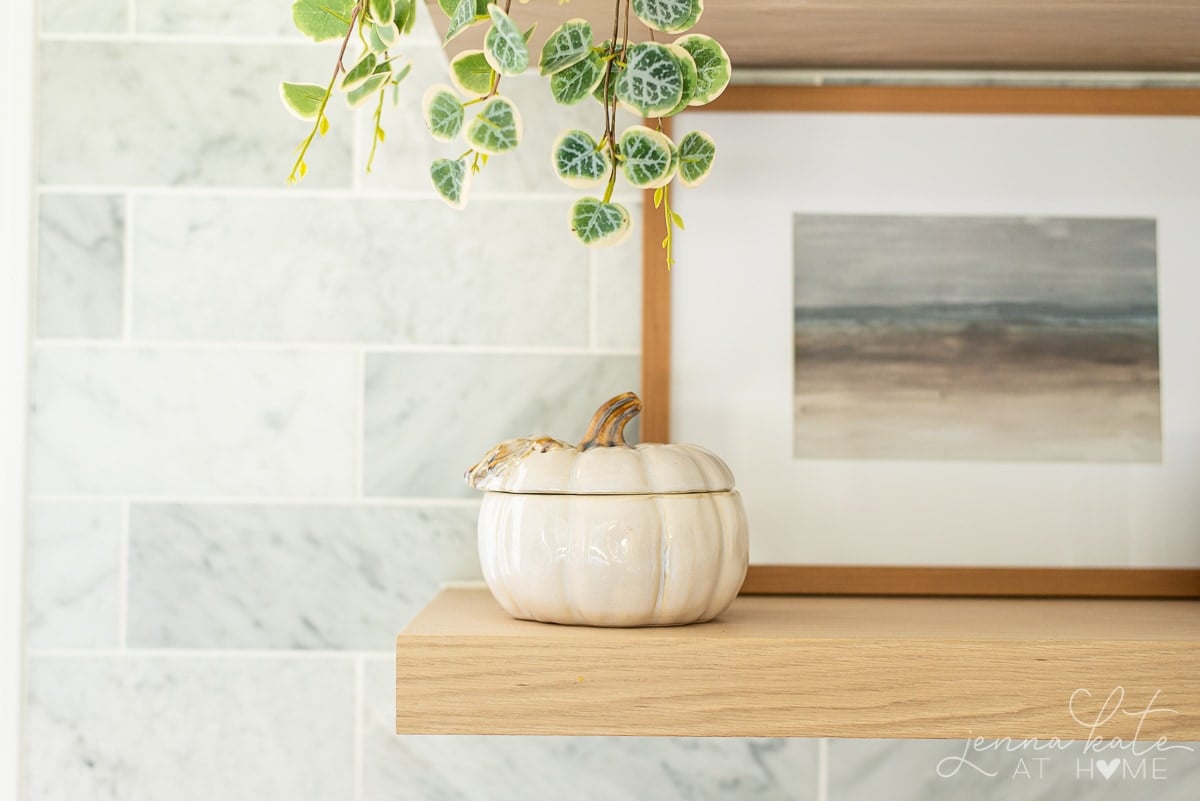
left=479, top=490, right=749, bottom=626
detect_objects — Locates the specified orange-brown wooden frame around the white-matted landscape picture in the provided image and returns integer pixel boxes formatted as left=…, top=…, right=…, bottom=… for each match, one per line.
left=642, top=85, right=1200, bottom=598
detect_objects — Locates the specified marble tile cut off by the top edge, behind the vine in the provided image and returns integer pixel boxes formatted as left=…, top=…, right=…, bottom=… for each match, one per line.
left=136, top=0, right=438, bottom=43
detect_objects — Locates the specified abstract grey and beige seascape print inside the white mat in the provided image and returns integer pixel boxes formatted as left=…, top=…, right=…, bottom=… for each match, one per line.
left=793, top=213, right=1162, bottom=463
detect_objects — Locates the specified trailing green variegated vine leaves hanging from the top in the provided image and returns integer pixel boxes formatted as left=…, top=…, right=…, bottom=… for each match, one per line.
left=280, top=0, right=731, bottom=262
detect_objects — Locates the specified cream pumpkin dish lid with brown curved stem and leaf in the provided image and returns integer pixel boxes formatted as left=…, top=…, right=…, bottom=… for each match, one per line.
left=466, top=392, right=733, bottom=495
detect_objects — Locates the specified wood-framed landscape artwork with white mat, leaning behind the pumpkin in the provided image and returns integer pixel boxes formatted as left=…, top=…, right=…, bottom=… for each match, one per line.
left=643, top=86, right=1200, bottom=597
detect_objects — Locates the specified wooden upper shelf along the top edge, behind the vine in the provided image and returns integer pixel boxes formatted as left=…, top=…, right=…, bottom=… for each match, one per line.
left=428, top=0, right=1200, bottom=70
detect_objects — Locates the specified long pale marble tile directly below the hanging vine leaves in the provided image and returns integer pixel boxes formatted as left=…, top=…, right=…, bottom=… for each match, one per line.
left=133, top=197, right=588, bottom=347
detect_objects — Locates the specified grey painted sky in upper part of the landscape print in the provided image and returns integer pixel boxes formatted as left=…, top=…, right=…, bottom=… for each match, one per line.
left=793, top=215, right=1158, bottom=307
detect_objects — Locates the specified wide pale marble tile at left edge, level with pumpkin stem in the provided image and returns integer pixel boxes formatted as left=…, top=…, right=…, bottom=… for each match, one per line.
left=30, top=347, right=358, bottom=498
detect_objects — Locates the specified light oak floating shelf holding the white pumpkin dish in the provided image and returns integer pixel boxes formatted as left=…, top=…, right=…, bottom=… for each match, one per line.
left=396, top=588, right=1200, bottom=741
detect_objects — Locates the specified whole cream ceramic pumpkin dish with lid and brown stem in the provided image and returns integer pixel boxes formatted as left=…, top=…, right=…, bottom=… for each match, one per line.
left=467, top=392, right=749, bottom=626
